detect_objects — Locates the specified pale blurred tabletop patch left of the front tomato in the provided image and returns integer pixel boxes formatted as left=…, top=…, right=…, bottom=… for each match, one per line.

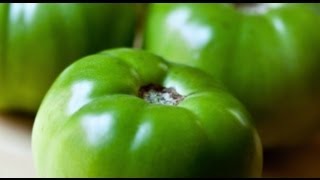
left=0, top=114, right=36, bottom=178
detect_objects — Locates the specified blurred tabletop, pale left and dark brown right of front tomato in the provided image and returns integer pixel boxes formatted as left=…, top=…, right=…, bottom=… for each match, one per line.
left=0, top=115, right=320, bottom=178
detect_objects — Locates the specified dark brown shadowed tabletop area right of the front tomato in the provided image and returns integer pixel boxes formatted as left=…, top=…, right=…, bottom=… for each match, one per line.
left=263, top=133, right=320, bottom=178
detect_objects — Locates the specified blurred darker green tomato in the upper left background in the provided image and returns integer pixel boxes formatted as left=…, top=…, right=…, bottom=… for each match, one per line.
left=0, top=3, right=136, bottom=114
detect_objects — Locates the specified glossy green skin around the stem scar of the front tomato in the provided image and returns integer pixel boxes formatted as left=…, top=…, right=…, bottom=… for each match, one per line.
left=32, top=48, right=262, bottom=177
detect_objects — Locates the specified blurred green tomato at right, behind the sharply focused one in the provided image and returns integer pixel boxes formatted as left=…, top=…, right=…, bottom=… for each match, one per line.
left=144, top=3, right=320, bottom=148
